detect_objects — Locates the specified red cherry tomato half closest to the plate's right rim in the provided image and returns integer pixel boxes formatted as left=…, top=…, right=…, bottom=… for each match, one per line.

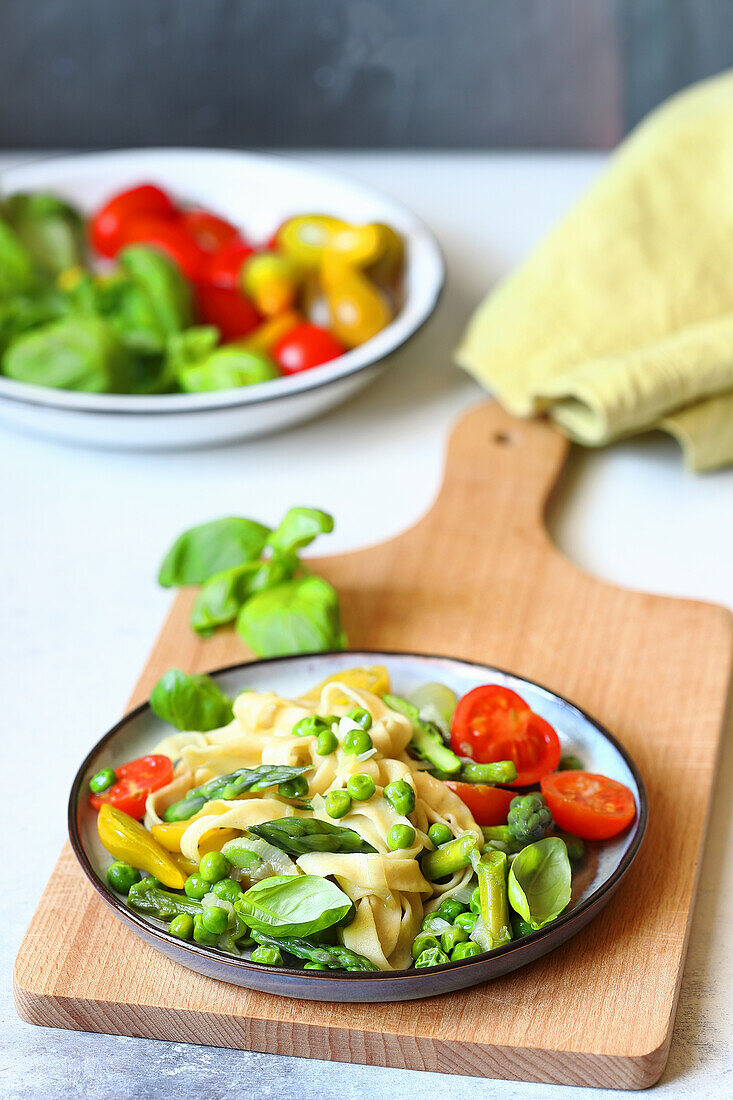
left=540, top=771, right=636, bottom=840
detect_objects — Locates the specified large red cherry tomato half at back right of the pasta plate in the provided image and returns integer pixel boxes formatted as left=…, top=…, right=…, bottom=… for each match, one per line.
left=450, top=684, right=560, bottom=787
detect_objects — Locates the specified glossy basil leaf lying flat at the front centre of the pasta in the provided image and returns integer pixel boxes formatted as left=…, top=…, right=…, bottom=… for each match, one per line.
left=234, top=875, right=351, bottom=936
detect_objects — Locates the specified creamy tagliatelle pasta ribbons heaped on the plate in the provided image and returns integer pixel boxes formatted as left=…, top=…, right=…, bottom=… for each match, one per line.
left=145, top=682, right=483, bottom=970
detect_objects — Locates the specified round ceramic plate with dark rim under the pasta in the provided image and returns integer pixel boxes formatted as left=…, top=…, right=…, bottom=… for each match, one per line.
left=68, top=651, right=648, bottom=1001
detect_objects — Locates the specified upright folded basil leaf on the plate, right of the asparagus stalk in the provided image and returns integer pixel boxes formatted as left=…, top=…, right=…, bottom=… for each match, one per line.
left=508, top=836, right=571, bottom=931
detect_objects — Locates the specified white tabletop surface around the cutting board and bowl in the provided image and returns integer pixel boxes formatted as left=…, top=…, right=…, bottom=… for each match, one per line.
left=0, top=153, right=733, bottom=1100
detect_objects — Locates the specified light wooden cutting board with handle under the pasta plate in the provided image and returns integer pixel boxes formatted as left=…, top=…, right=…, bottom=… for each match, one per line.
left=15, top=404, right=733, bottom=1088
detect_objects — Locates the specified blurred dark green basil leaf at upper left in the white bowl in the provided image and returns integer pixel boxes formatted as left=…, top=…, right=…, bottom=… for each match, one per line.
left=3, top=193, right=85, bottom=275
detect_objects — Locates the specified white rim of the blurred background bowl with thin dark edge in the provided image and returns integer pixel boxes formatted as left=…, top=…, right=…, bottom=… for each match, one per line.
left=0, top=147, right=446, bottom=416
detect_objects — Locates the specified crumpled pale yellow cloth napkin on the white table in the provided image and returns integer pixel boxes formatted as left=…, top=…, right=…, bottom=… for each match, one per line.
left=457, top=72, right=733, bottom=470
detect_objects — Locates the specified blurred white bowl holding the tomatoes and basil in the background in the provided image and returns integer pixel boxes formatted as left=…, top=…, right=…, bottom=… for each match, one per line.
left=0, top=149, right=445, bottom=449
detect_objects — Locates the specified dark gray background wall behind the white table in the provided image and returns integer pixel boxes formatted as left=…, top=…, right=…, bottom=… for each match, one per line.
left=0, top=0, right=733, bottom=149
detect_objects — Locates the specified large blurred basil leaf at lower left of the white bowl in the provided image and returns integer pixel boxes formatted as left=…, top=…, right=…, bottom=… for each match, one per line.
left=2, top=317, right=133, bottom=394
